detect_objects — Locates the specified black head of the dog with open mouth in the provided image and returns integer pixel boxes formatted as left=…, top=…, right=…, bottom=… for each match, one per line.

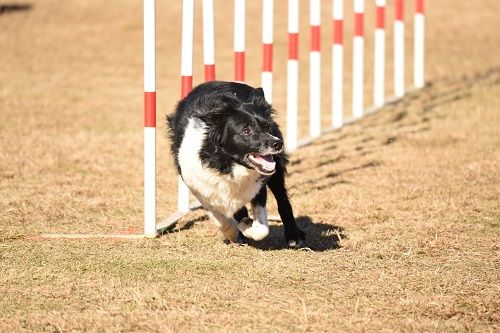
left=200, top=83, right=283, bottom=176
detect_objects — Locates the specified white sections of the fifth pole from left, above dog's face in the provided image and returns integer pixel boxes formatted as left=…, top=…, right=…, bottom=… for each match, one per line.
left=261, top=0, right=274, bottom=104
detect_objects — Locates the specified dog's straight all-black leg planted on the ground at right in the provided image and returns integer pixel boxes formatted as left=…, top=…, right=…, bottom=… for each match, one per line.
left=267, top=172, right=306, bottom=247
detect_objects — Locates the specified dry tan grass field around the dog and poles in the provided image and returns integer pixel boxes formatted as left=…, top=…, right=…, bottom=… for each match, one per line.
left=0, top=0, right=500, bottom=332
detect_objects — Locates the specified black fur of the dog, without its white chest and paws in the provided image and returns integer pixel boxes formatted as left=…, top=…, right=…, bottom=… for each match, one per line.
left=167, top=81, right=305, bottom=247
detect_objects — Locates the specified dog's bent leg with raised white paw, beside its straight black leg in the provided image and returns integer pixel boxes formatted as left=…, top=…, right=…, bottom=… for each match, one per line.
left=238, top=186, right=269, bottom=241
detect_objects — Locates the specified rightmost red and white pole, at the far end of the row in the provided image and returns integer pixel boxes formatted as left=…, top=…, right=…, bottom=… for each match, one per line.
left=413, top=0, right=425, bottom=88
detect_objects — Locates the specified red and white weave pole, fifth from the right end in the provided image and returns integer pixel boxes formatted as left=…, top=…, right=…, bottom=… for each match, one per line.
left=332, top=0, right=344, bottom=128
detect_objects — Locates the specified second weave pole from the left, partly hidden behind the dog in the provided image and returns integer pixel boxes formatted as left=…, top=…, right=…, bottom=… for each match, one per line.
left=177, top=0, right=194, bottom=212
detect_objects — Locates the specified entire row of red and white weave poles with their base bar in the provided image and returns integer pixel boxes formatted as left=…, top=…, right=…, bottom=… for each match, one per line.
left=42, top=0, right=425, bottom=238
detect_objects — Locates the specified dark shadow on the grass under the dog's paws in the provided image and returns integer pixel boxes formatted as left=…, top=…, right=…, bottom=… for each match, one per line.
left=248, top=216, right=346, bottom=252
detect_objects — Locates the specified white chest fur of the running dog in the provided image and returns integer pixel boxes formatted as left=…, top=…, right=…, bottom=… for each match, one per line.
left=178, top=119, right=262, bottom=217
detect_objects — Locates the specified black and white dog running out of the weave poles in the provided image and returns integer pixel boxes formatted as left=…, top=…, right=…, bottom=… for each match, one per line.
left=167, top=81, right=305, bottom=247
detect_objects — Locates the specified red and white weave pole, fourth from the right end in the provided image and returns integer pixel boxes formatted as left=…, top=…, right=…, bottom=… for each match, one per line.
left=352, top=0, right=365, bottom=118
